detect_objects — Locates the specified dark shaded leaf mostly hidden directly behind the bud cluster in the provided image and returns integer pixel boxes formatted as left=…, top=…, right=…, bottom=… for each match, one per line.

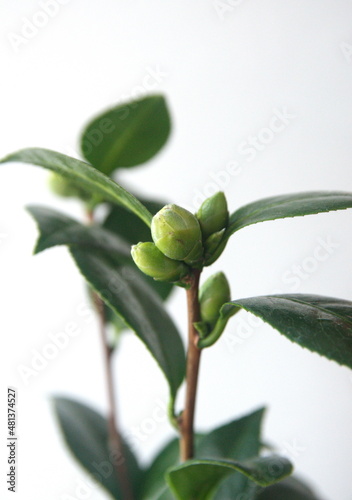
left=103, top=198, right=174, bottom=300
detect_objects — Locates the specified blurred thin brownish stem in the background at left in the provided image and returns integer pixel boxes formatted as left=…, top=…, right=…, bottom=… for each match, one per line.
left=94, top=293, right=133, bottom=500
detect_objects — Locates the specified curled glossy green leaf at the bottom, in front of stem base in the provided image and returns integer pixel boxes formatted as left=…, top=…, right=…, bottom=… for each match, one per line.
left=167, top=455, right=292, bottom=500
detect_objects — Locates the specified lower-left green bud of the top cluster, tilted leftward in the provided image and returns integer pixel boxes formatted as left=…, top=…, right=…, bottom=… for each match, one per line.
left=131, top=241, right=189, bottom=281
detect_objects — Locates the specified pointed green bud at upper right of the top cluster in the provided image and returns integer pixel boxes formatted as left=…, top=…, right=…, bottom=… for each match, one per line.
left=197, top=191, right=229, bottom=240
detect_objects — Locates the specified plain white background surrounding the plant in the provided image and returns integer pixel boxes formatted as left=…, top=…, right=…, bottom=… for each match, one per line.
left=0, top=0, right=352, bottom=500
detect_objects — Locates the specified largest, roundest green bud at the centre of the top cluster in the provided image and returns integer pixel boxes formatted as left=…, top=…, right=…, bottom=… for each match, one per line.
left=151, top=205, right=203, bottom=265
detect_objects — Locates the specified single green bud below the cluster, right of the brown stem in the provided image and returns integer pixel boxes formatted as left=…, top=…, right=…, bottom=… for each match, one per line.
left=199, top=273, right=230, bottom=327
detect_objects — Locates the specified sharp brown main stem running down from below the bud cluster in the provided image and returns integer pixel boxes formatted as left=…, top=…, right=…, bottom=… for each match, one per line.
left=180, top=271, right=201, bottom=461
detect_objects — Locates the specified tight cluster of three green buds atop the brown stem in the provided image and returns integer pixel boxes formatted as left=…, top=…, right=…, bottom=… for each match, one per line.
left=132, top=193, right=228, bottom=282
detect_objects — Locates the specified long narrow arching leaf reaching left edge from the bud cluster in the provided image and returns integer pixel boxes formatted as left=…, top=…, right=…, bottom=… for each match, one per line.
left=0, top=148, right=152, bottom=227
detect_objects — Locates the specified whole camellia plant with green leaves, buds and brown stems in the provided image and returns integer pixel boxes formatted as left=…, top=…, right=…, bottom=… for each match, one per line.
left=2, top=95, right=352, bottom=500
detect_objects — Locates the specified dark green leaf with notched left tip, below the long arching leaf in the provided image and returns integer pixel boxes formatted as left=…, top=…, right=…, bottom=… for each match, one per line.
left=27, top=205, right=132, bottom=262
